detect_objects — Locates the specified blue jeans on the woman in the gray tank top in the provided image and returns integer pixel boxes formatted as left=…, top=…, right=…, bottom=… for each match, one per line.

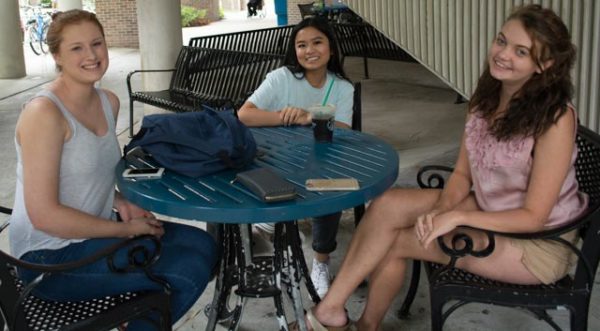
left=19, top=222, right=217, bottom=330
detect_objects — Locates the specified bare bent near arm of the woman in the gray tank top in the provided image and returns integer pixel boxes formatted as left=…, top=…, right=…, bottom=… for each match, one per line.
left=16, top=98, right=162, bottom=238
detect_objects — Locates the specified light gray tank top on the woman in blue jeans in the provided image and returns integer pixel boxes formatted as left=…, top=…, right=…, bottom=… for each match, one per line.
left=9, top=89, right=121, bottom=258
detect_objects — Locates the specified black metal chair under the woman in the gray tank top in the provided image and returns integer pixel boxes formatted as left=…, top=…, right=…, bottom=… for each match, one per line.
left=0, top=207, right=171, bottom=331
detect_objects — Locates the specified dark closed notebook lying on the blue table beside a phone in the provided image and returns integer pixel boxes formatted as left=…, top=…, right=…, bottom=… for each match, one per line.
left=236, top=168, right=296, bottom=202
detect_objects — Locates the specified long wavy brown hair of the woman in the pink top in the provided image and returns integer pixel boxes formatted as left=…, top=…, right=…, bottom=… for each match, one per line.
left=469, top=5, right=576, bottom=140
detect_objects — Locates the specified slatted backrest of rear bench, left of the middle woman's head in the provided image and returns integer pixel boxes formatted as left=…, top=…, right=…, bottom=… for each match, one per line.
left=188, top=25, right=294, bottom=55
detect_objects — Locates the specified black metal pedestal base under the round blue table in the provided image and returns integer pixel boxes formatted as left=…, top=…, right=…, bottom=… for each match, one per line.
left=205, top=221, right=320, bottom=331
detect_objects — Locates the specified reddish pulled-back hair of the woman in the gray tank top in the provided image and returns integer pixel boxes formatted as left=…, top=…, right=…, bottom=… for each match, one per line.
left=46, top=9, right=104, bottom=71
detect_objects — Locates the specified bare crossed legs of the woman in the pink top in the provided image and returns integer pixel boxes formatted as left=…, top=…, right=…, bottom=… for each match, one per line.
left=314, top=189, right=539, bottom=331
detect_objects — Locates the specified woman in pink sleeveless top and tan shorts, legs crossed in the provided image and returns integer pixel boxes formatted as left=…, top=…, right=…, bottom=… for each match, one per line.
left=296, top=5, right=588, bottom=331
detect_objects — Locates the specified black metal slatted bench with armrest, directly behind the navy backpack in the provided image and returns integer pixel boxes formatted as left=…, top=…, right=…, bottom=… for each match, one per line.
left=127, top=46, right=283, bottom=136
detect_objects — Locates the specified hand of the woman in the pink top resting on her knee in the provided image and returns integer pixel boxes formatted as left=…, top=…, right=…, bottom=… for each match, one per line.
left=415, top=210, right=462, bottom=248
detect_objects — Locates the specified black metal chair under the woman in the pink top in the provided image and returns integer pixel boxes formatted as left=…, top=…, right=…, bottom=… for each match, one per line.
left=399, top=126, right=600, bottom=331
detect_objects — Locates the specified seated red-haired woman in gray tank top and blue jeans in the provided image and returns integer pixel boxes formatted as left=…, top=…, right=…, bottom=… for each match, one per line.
left=10, top=10, right=216, bottom=330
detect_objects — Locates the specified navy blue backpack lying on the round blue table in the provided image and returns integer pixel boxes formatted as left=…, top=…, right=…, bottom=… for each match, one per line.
left=124, top=107, right=256, bottom=177
